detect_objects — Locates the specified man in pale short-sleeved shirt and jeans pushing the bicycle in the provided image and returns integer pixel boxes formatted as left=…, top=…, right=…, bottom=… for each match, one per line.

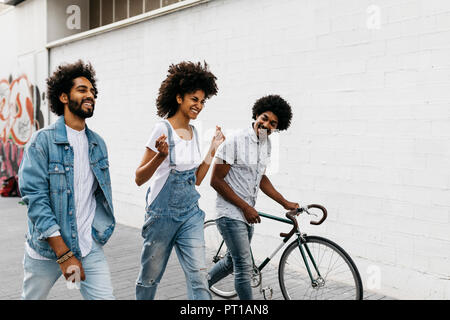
left=208, top=95, right=299, bottom=300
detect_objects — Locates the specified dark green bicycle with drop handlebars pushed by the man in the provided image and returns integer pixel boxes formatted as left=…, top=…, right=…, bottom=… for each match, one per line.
left=204, top=204, right=363, bottom=300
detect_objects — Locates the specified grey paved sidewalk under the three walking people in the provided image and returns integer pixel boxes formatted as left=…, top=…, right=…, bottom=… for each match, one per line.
left=0, top=198, right=390, bottom=300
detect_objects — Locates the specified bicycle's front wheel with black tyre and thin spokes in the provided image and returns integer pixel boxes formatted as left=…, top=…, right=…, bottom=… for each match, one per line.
left=278, top=236, right=363, bottom=300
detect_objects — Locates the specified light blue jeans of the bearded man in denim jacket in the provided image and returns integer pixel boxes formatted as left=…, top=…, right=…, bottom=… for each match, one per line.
left=22, top=240, right=115, bottom=300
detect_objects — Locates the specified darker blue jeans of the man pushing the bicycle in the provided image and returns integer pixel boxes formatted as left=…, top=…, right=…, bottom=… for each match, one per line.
left=208, top=217, right=254, bottom=300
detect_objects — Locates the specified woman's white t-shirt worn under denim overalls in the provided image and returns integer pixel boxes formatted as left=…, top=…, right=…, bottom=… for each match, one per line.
left=146, top=120, right=202, bottom=205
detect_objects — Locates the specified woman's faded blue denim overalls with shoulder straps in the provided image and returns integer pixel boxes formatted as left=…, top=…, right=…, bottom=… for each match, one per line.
left=136, top=121, right=211, bottom=300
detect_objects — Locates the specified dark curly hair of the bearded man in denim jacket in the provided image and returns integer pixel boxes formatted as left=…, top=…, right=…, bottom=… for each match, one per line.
left=47, top=60, right=98, bottom=116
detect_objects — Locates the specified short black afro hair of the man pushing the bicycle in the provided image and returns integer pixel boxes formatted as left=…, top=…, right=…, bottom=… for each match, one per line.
left=252, top=95, right=292, bottom=131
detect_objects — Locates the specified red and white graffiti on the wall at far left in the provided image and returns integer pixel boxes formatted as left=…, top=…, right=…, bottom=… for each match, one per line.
left=0, top=75, right=44, bottom=179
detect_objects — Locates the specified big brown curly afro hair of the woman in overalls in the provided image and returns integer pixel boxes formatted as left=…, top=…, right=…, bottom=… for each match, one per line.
left=156, top=61, right=218, bottom=118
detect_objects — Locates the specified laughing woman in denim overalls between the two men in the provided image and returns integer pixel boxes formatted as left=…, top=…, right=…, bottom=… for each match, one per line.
left=136, top=62, right=225, bottom=300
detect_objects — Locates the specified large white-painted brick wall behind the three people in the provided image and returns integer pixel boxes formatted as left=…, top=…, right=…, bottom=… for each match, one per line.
left=47, top=0, right=450, bottom=299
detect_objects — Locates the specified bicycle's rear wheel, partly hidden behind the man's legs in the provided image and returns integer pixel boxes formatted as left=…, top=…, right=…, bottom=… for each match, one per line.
left=203, top=220, right=237, bottom=298
